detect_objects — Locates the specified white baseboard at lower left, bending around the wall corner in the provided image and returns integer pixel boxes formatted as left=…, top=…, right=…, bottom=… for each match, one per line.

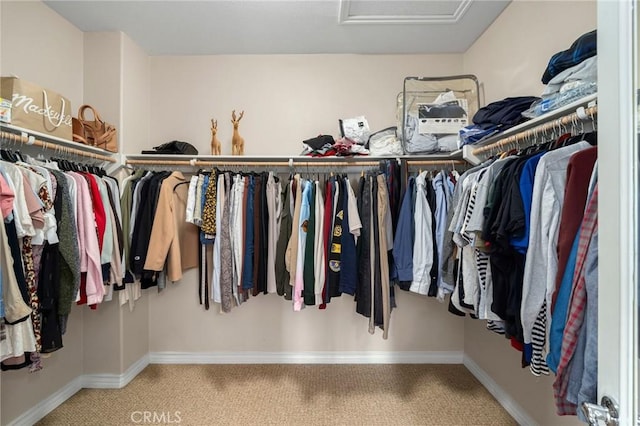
left=9, top=355, right=149, bottom=426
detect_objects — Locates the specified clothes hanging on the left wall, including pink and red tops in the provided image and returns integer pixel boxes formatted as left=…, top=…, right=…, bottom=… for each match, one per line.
left=0, top=156, right=121, bottom=372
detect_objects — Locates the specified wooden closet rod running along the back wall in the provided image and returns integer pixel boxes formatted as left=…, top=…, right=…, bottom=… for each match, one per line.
left=126, top=160, right=467, bottom=167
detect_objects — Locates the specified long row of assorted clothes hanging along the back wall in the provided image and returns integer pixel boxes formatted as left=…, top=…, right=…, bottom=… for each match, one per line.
left=169, top=162, right=455, bottom=339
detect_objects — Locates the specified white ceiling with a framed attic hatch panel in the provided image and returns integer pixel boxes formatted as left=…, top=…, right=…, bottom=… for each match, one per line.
left=45, top=0, right=511, bottom=55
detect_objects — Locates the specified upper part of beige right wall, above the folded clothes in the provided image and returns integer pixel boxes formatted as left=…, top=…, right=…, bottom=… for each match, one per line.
left=464, top=0, right=596, bottom=104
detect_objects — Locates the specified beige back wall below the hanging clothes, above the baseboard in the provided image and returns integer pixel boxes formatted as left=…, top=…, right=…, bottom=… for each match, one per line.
left=149, top=271, right=463, bottom=352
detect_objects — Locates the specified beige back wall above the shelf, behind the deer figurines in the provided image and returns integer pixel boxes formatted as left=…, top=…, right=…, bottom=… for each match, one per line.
left=148, top=55, right=462, bottom=155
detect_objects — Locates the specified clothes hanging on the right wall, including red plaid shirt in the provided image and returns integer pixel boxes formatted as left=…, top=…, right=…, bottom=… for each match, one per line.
left=441, top=127, right=597, bottom=415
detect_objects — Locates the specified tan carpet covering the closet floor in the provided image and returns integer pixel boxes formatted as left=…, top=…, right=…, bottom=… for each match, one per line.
left=37, top=364, right=517, bottom=426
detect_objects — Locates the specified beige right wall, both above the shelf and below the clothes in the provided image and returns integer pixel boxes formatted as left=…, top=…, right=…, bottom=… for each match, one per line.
left=464, top=0, right=596, bottom=425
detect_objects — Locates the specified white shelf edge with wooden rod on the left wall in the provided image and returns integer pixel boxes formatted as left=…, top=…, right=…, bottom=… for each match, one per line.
left=0, top=123, right=118, bottom=163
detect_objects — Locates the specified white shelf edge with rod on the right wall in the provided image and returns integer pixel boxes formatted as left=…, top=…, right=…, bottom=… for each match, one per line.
left=455, top=93, right=598, bottom=164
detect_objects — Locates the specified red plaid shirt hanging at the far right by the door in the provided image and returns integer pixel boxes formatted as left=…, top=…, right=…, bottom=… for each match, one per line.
left=553, top=185, right=598, bottom=416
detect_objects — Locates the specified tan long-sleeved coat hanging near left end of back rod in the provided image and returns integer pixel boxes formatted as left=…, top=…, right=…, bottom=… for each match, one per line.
left=144, top=172, right=200, bottom=281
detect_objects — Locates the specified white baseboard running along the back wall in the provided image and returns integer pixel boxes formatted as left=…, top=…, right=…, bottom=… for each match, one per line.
left=149, top=351, right=463, bottom=364
